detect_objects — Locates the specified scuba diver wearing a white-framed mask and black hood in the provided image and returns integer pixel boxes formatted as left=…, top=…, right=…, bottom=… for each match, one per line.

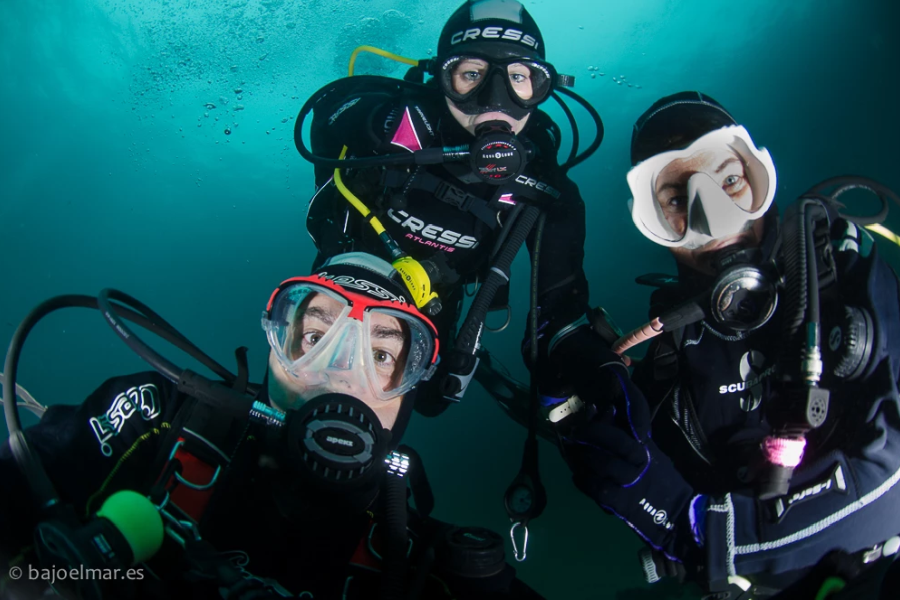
left=555, top=91, right=900, bottom=600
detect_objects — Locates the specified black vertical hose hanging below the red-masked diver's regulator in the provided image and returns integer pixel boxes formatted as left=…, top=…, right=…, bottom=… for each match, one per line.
left=379, top=472, right=409, bottom=600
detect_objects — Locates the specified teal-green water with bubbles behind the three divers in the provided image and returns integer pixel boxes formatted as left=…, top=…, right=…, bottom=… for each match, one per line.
left=0, top=0, right=900, bottom=600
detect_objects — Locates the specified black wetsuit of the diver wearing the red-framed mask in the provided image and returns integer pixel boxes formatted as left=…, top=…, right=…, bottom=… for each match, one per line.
left=0, top=371, right=541, bottom=600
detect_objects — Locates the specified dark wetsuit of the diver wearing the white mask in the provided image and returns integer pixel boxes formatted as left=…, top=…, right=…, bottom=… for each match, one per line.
left=632, top=213, right=900, bottom=589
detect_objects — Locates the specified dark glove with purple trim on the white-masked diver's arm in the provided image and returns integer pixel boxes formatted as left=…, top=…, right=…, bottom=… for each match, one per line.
left=562, top=369, right=705, bottom=579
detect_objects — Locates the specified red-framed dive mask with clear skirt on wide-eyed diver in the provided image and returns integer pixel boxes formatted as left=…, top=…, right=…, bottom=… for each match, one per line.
left=262, top=276, right=438, bottom=401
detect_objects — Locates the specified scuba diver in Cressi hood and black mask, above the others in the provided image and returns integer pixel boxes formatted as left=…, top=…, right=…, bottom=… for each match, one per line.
left=294, top=0, right=603, bottom=417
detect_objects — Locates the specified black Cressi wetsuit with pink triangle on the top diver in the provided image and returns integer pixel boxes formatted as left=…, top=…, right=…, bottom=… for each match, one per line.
left=307, top=80, right=588, bottom=415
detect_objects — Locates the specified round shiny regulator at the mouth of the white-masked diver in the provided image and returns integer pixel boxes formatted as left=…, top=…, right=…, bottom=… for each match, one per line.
left=710, top=246, right=778, bottom=332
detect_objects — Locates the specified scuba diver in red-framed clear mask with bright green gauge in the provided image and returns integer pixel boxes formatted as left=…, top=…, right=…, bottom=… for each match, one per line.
left=0, top=253, right=541, bottom=600
